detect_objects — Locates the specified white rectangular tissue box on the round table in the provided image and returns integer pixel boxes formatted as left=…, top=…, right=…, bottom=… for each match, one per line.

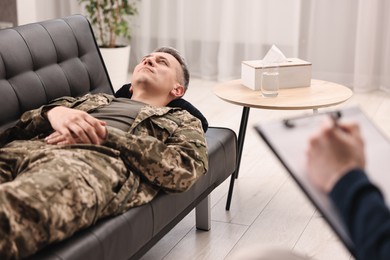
left=241, top=58, right=311, bottom=90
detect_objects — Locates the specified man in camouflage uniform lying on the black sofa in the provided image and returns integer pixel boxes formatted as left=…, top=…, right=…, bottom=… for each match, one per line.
left=0, top=47, right=208, bottom=259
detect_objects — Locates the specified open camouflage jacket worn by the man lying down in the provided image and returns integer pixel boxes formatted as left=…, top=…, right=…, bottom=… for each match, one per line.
left=0, top=94, right=208, bottom=208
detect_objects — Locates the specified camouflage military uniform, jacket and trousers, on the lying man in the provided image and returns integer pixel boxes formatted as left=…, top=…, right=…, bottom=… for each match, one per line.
left=0, top=94, right=208, bottom=259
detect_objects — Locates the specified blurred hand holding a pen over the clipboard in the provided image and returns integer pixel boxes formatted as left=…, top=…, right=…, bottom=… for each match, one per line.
left=306, top=114, right=365, bottom=192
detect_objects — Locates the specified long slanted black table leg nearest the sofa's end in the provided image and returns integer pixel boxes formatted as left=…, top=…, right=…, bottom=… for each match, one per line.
left=226, top=107, right=249, bottom=210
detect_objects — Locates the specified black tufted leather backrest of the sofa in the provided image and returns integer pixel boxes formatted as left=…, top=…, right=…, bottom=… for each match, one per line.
left=0, top=15, right=113, bottom=129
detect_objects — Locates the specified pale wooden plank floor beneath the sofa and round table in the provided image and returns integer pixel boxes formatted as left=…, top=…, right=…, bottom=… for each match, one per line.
left=142, top=79, right=390, bottom=260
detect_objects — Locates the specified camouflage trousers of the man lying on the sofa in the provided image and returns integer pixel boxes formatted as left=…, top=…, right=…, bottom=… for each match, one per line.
left=0, top=141, right=139, bottom=259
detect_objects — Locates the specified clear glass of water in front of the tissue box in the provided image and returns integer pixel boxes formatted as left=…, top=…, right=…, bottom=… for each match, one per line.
left=261, top=63, right=279, bottom=97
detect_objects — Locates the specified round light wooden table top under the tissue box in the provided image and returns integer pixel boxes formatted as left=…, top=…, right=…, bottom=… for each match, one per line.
left=214, top=79, right=352, bottom=110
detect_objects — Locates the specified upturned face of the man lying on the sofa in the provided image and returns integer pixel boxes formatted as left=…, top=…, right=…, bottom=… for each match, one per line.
left=132, top=52, right=181, bottom=98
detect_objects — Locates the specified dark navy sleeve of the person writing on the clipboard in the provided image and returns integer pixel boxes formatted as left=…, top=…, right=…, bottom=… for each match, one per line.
left=330, top=169, right=390, bottom=260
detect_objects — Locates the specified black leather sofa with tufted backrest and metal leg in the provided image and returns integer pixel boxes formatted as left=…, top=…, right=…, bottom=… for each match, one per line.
left=0, top=15, right=236, bottom=260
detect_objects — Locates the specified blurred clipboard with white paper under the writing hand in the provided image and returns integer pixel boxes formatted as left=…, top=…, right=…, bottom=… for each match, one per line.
left=255, top=107, right=390, bottom=255
